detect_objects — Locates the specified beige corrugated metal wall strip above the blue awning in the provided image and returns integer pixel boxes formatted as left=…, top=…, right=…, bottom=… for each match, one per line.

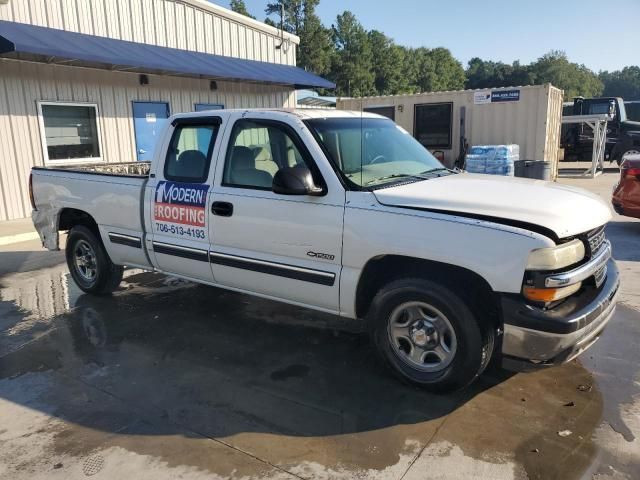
left=0, top=0, right=299, bottom=65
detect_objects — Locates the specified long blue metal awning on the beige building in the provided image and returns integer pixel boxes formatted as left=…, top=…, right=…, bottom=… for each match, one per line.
left=0, top=21, right=335, bottom=88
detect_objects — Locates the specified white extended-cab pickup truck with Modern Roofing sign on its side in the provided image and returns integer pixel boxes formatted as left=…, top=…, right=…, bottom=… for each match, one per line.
left=30, top=110, right=619, bottom=391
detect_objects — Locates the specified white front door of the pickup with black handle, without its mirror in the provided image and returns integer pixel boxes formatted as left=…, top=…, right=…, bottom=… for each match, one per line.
left=209, top=112, right=345, bottom=312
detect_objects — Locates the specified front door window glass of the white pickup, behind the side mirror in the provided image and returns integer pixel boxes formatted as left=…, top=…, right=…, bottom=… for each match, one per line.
left=222, top=120, right=306, bottom=190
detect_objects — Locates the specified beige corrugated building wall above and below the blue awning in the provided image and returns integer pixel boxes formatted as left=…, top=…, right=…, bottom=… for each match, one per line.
left=0, top=0, right=299, bottom=220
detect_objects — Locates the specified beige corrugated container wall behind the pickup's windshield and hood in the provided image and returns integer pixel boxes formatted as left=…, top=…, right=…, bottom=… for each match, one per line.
left=337, top=85, right=562, bottom=171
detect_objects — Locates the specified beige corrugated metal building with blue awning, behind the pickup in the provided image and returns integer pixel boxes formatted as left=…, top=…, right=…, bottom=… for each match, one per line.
left=0, top=0, right=332, bottom=220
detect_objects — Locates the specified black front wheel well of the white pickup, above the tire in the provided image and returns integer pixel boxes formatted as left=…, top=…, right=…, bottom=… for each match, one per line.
left=356, top=255, right=502, bottom=328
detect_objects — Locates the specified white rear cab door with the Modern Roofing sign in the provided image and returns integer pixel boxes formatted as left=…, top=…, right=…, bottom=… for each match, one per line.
left=148, top=117, right=221, bottom=282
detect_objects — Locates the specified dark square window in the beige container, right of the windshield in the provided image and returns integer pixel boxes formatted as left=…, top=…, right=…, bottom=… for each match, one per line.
left=413, top=103, right=453, bottom=149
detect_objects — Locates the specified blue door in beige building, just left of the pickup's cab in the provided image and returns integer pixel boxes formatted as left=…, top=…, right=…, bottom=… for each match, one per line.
left=133, top=102, right=169, bottom=161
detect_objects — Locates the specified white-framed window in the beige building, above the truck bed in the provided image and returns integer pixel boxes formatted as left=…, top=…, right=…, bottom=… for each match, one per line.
left=38, top=102, right=102, bottom=164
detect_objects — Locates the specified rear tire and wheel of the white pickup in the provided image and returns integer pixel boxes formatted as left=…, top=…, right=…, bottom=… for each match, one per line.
left=65, top=225, right=124, bottom=295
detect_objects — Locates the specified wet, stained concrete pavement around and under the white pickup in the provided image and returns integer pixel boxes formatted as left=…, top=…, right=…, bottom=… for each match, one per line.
left=0, top=171, right=640, bottom=479
